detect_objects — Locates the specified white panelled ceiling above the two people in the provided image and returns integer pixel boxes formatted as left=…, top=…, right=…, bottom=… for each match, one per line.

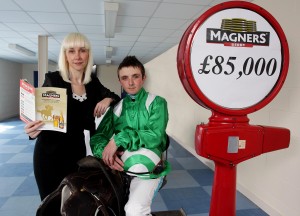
left=0, top=0, right=239, bottom=65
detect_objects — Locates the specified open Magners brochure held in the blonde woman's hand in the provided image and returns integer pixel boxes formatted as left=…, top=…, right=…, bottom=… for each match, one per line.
left=20, top=79, right=67, bottom=133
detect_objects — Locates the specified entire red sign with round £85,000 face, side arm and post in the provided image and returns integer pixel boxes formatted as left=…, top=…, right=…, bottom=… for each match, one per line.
left=177, top=1, right=290, bottom=216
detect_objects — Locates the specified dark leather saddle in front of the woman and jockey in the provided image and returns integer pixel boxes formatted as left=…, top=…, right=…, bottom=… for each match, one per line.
left=36, top=155, right=130, bottom=216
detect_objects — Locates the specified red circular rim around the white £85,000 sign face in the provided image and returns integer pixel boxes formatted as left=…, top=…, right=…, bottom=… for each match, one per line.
left=177, top=1, right=289, bottom=115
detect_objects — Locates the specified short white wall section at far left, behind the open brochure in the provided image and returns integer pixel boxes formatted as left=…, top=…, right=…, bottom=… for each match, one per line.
left=0, top=59, right=22, bottom=121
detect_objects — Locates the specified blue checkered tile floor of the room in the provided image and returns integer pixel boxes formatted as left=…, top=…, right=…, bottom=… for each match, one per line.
left=0, top=118, right=268, bottom=216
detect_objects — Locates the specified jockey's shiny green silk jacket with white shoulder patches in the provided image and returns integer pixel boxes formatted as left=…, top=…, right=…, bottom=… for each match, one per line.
left=90, top=88, right=168, bottom=158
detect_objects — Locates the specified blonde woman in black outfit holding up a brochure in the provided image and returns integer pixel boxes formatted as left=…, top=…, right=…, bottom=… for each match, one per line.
left=25, top=33, right=120, bottom=200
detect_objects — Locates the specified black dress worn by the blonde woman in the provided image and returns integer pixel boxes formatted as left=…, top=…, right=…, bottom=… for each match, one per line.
left=34, top=72, right=120, bottom=199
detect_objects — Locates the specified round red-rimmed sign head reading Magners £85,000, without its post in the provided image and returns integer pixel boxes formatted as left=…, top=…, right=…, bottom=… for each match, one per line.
left=177, top=1, right=289, bottom=115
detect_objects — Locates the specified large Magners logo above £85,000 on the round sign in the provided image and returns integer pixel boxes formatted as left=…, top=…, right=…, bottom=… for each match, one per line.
left=206, top=18, right=270, bottom=47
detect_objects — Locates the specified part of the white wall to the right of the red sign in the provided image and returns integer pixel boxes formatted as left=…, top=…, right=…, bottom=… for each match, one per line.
left=238, top=0, right=300, bottom=216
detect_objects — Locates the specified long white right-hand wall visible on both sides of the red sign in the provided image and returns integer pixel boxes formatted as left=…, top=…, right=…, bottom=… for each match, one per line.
left=145, top=0, right=300, bottom=216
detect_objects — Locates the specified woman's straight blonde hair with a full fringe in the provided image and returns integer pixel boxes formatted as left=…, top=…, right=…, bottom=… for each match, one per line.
left=58, top=32, right=94, bottom=84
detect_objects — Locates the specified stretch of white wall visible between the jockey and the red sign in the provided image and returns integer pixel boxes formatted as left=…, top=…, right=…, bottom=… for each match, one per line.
left=145, top=46, right=211, bottom=155
